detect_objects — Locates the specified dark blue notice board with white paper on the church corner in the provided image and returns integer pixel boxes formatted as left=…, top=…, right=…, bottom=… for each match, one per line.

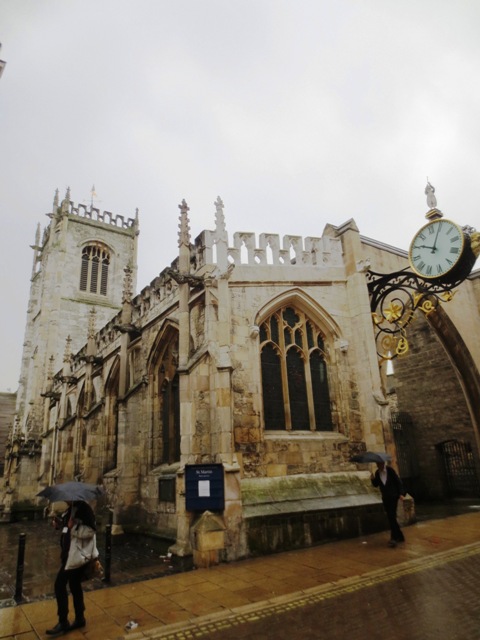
left=185, top=464, right=225, bottom=511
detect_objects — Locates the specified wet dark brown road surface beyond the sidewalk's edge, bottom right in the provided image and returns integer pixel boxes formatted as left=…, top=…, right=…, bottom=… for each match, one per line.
left=188, top=543, right=480, bottom=640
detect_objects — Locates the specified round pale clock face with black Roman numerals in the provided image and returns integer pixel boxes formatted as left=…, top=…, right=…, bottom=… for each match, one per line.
left=408, top=219, right=465, bottom=278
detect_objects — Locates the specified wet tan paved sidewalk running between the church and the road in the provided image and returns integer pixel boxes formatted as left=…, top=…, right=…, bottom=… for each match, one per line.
left=0, top=511, right=480, bottom=640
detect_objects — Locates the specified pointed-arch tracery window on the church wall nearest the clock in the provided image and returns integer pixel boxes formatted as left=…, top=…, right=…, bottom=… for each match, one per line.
left=260, top=307, right=333, bottom=431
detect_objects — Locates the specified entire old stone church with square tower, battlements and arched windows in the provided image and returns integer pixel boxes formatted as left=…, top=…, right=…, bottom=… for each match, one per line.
left=0, top=192, right=480, bottom=564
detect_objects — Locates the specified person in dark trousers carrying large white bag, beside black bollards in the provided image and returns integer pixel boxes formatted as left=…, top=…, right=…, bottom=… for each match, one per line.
left=46, top=500, right=98, bottom=636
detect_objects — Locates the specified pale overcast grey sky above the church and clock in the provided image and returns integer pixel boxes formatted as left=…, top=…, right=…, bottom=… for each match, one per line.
left=0, top=0, right=480, bottom=391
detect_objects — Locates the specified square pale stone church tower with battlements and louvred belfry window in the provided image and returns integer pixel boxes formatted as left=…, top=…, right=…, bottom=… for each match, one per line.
left=15, top=189, right=139, bottom=437
